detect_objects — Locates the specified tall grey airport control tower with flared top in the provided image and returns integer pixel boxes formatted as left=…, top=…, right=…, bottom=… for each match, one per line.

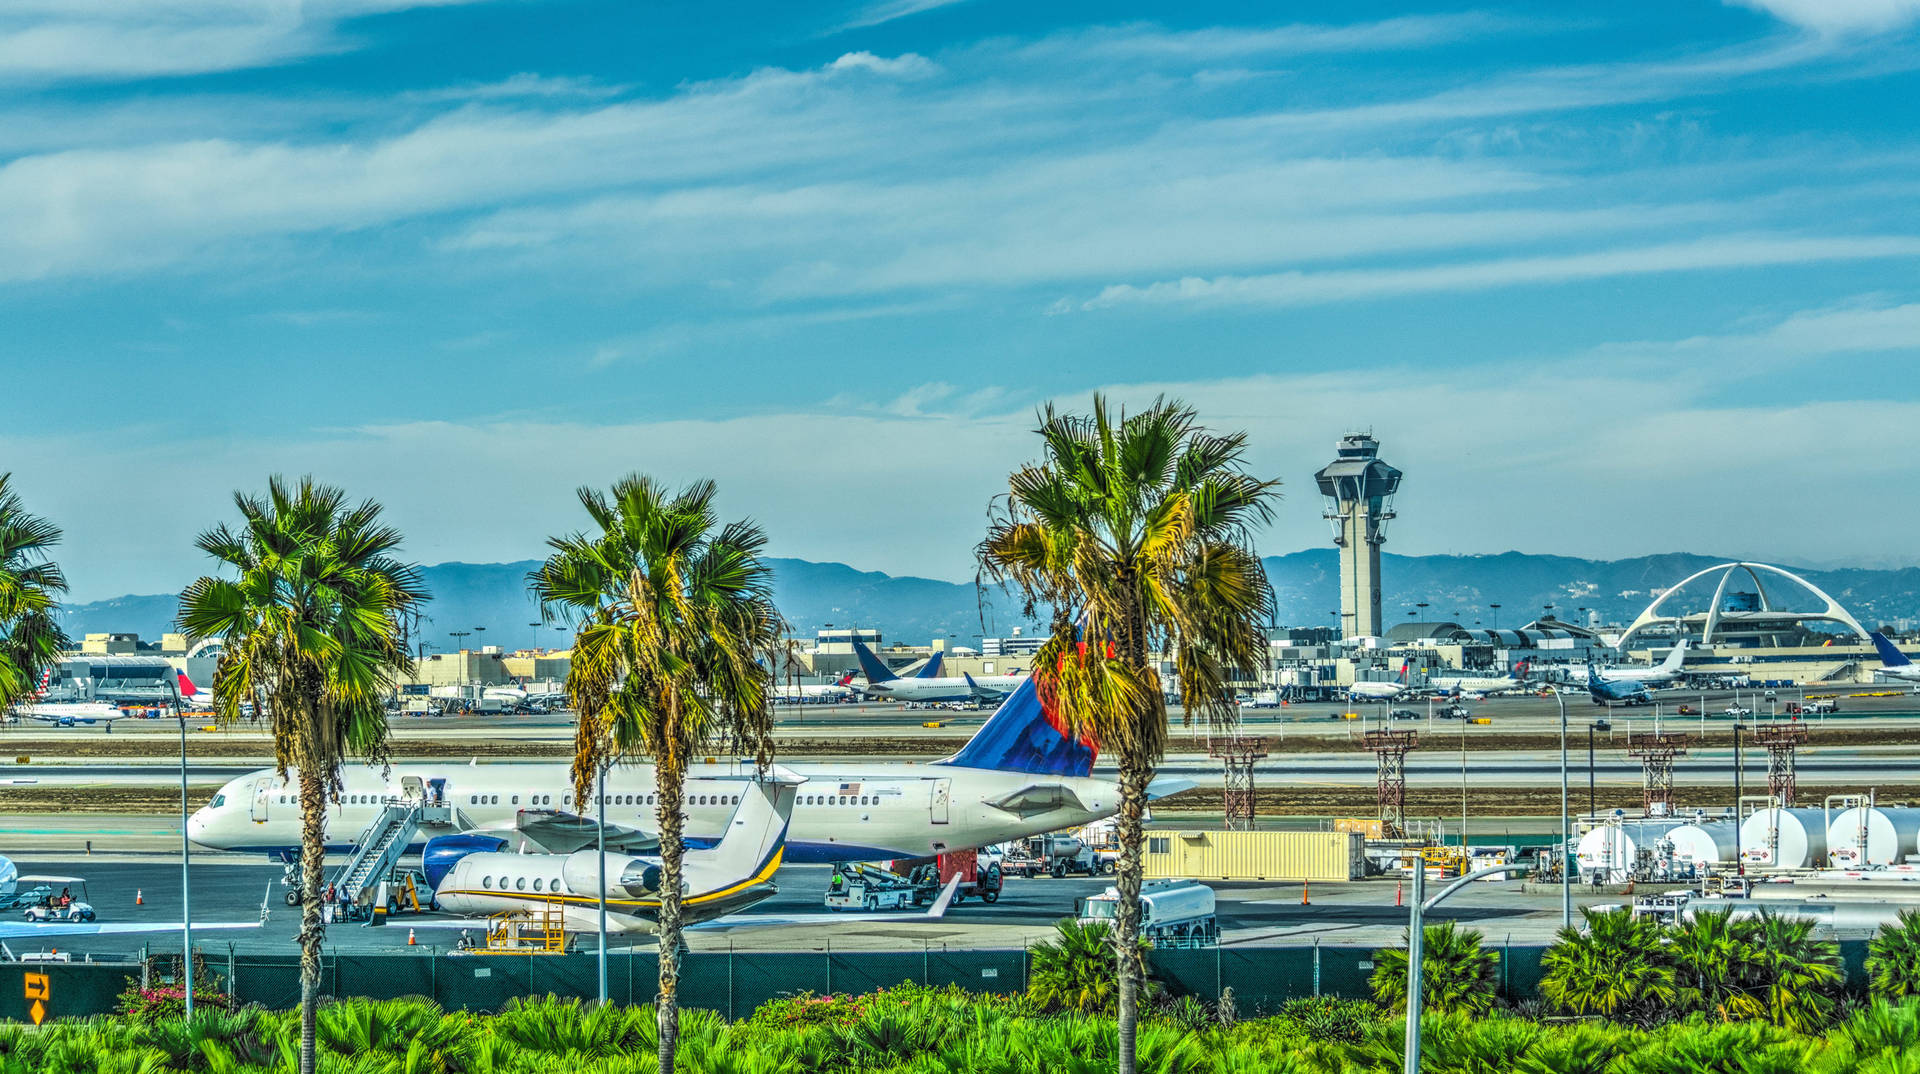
left=1313, top=432, right=1400, bottom=638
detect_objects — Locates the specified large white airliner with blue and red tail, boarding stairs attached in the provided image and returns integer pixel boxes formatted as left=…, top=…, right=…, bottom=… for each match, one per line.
left=186, top=684, right=1121, bottom=863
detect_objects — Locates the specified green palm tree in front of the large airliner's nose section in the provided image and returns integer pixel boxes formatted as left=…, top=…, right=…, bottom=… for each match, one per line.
left=179, top=476, right=426, bottom=1074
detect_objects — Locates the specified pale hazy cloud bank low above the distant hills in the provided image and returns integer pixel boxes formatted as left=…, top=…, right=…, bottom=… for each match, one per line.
left=22, top=340, right=1920, bottom=599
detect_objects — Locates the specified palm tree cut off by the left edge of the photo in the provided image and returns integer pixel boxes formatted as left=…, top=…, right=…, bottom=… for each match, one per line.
left=0, top=473, right=67, bottom=713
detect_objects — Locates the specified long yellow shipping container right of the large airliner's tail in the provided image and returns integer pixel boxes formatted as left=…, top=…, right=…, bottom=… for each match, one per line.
left=1144, top=828, right=1367, bottom=882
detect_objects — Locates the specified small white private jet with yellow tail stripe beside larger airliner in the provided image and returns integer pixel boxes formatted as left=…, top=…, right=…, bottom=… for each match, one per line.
left=424, top=769, right=806, bottom=932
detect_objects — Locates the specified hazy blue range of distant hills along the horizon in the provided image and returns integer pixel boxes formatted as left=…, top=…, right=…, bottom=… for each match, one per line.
left=52, top=548, right=1920, bottom=651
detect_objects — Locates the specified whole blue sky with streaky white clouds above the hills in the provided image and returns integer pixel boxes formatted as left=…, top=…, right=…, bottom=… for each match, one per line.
left=0, top=0, right=1920, bottom=599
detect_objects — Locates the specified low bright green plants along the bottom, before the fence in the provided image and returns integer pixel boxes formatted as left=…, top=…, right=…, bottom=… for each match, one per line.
left=0, top=986, right=1920, bottom=1074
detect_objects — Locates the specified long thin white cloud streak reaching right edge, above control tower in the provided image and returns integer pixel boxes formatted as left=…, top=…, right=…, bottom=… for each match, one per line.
left=1081, top=234, right=1920, bottom=309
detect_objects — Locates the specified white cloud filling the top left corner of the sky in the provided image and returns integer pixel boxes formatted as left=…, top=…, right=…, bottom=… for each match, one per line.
left=0, top=0, right=503, bottom=83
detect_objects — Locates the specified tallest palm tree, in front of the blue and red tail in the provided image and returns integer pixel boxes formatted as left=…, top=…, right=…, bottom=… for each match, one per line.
left=977, top=396, right=1279, bottom=1074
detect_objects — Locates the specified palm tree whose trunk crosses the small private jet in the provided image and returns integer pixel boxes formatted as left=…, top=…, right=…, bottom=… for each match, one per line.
left=528, top=475, right=781, bottom=1074
